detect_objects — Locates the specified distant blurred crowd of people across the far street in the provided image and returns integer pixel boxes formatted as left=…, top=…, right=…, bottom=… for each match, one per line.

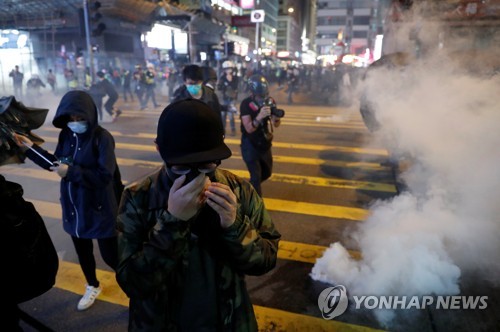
left=5, top=60, right=362, bottom=111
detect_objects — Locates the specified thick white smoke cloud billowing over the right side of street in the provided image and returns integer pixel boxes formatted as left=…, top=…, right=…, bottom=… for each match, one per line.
left=311, top=20, right=500, bottom=324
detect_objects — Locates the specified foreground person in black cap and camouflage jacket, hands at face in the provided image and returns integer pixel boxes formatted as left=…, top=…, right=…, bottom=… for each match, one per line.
left=116, top=100, right=281, bottom=331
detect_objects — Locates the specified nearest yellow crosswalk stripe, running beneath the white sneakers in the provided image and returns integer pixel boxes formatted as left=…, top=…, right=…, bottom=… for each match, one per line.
left=55, top=261, right=378, bottom=332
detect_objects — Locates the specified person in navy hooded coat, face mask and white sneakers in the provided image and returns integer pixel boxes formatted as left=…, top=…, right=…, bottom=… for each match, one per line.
left=16, top=90, right=119, bottom=310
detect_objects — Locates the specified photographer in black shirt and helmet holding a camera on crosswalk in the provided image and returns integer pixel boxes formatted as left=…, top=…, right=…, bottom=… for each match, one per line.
left=240, top=75, right=284, bottom=196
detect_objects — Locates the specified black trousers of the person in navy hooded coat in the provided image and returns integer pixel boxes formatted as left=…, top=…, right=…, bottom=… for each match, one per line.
left=71, top=236, right=118, bottom=287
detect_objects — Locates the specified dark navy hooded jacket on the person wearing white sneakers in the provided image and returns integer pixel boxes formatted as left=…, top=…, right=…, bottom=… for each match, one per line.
left=26, top=90, right=118, bottom=239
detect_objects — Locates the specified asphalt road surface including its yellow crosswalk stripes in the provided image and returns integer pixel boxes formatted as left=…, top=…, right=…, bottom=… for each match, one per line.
left=2, top=87, right=500, bottom=331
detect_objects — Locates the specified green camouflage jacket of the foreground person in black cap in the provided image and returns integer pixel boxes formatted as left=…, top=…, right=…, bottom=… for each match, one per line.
left=116, top=168, right=281, bottom=332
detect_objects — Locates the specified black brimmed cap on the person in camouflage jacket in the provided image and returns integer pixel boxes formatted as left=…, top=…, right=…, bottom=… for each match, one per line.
left=156, top=99, right=231, bottom=164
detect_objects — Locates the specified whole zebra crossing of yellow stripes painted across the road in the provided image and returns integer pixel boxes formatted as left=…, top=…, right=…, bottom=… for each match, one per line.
left=1, top=103, right=396, bottom=331
